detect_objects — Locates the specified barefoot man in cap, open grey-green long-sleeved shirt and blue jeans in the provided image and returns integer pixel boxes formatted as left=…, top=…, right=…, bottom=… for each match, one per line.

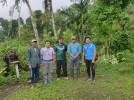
left=27, top=40, right=42, bottom=89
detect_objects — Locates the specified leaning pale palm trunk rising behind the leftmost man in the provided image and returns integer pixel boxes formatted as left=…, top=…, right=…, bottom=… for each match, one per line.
left=25, top=0, right=41, bottom=49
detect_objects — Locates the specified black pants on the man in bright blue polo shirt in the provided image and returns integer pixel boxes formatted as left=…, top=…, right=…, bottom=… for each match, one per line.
left=85, top=60, right=95, bottom=78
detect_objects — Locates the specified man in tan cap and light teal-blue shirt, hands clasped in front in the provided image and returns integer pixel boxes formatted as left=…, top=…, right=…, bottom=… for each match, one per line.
left=68, top=36, right=81, bottom=80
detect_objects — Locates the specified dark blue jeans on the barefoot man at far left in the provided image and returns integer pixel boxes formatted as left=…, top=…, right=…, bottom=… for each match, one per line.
left=30, top=66, right=40, bottom=85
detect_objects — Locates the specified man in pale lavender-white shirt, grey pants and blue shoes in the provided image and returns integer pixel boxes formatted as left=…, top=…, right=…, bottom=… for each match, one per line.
left=41, top=40, right=55, bottom=84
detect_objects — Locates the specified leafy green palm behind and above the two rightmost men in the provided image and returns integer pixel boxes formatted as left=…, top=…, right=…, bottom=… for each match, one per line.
left=62, top=0, right=90, bottom=57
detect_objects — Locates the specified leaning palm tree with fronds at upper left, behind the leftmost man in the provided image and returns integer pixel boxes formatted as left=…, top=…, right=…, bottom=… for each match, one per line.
left=0, top=0, right=41, bottom=48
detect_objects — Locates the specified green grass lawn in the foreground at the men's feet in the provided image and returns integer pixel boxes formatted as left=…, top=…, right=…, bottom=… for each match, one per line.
left=5, top=54, right=134, bottom=100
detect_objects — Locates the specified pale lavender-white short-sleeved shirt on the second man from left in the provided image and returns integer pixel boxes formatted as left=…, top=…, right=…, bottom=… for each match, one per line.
left=41, top=47, right=55, bottom=60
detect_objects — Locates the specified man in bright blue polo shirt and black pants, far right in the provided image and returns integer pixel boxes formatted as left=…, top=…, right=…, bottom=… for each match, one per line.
left=82, top=37, right=96, bottom=82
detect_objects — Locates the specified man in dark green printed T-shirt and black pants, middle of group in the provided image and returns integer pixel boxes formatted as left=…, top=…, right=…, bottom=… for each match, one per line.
left=54, top=37, right=68, bottom=80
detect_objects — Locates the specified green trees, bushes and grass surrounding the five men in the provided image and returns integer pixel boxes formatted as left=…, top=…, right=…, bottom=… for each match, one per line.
left=0, top=0, right=134, bottom=100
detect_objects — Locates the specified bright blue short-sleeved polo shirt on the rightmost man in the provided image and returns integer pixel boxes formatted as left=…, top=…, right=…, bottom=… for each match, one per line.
left=83, top=43, right=96, bottom=60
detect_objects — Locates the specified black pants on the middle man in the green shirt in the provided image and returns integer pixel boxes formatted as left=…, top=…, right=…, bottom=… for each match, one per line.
left=56, top=60, right=67, bottom=78
